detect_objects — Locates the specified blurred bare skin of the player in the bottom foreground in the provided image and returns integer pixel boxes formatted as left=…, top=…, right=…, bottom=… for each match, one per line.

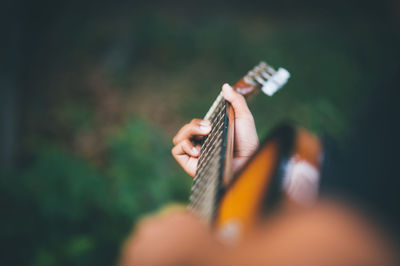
left=119, top=201, right=399, bottom=266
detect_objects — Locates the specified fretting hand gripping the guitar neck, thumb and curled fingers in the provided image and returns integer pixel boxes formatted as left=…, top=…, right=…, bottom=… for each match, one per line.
left=172, top=84, right=259, bottom=177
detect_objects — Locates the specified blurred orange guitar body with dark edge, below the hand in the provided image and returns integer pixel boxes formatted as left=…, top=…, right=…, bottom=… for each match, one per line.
left=213, top=125, right=322, bottom=241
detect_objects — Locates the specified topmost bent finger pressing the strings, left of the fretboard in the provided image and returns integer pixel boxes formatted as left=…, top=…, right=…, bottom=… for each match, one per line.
left=172, top=119, right=211, bottom=145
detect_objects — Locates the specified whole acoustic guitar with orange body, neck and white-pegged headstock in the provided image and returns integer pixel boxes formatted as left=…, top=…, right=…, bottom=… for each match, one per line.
left=189, top=62, right=323, bottom=242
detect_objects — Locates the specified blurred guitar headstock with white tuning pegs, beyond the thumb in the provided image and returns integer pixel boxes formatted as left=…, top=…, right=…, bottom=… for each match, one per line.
left=233, top=62, right=290, bottom=96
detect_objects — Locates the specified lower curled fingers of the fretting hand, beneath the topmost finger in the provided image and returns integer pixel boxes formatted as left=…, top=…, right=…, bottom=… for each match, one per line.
left=171, top=139, right=200, bottom=177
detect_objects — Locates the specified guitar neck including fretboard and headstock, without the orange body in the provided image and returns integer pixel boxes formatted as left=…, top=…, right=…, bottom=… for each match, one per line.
left=189, top=63, right=288, bottom=223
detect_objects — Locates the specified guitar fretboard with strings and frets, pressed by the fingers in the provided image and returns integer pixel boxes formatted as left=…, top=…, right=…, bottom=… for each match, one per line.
left=189, top=94, right=228, bottom=222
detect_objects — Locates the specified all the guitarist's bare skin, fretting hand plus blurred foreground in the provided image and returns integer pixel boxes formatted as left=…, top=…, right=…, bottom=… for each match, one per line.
left=119, top=84, right=400, bottom=266
